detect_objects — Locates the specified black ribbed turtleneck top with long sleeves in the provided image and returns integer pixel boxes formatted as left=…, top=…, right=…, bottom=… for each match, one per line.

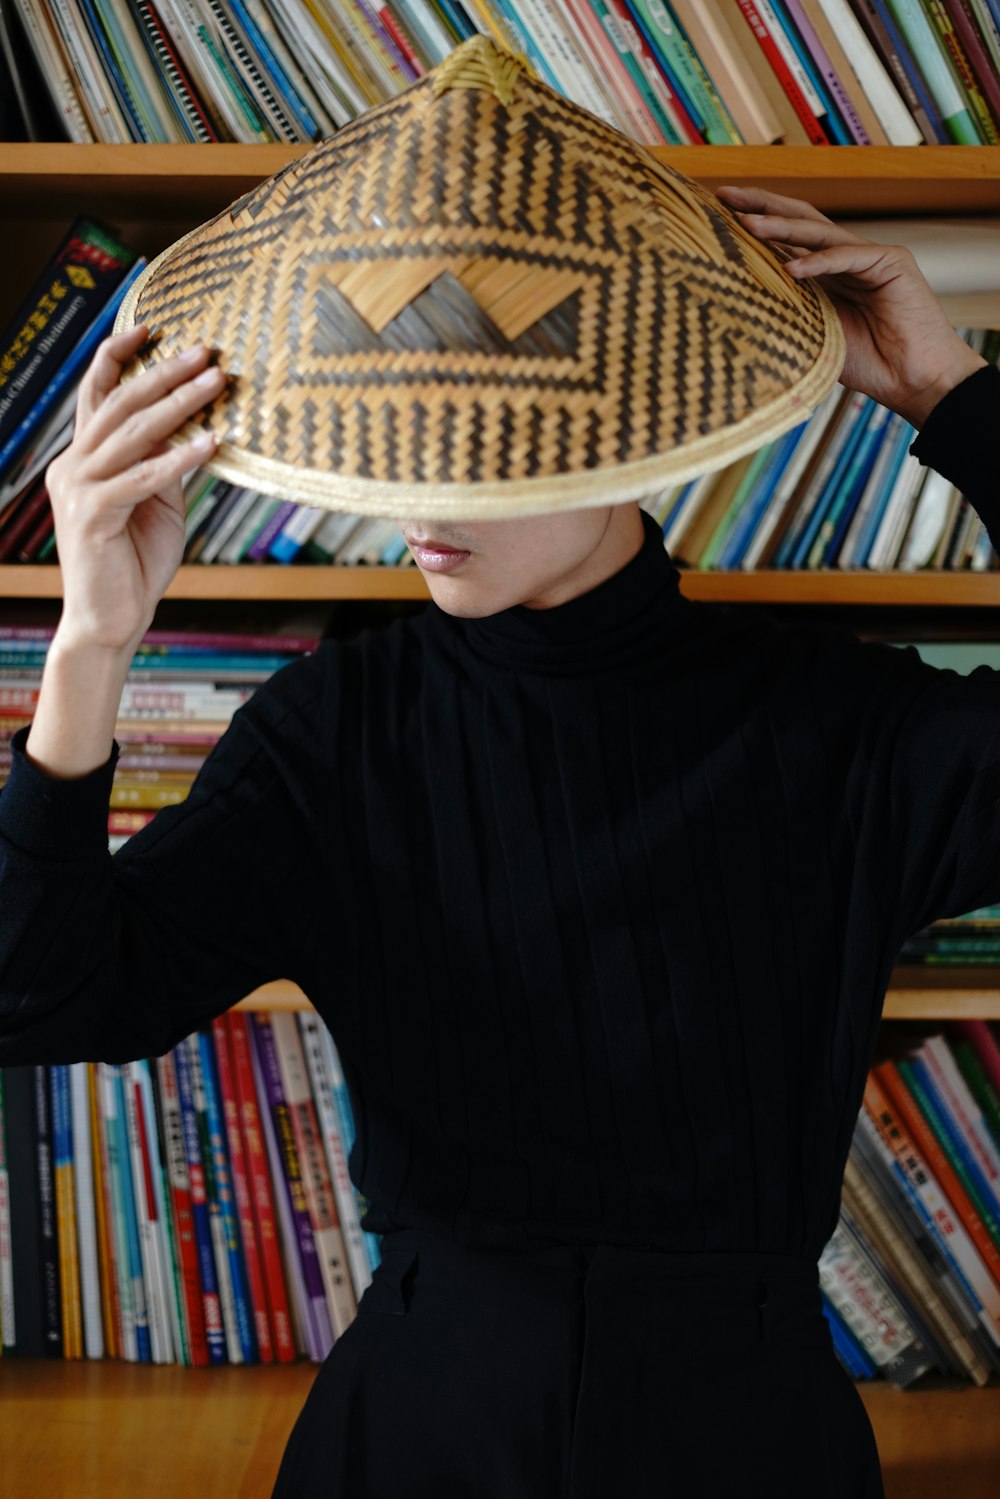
left=0, top=367, right=1000, bottom=1258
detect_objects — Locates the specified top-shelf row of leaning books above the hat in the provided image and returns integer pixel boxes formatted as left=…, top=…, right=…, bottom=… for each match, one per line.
left=0, top=0, right=1000, bottom=145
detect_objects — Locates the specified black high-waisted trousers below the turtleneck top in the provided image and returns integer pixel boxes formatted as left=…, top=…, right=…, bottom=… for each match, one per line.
left=273, top=1229, right=883, bottom=1499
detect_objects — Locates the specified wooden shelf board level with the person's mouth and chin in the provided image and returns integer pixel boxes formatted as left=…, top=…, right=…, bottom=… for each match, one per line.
left=0, top=562, right=1000, bottom=609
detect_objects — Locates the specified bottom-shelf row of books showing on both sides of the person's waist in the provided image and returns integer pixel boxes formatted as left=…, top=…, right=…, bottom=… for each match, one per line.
left=0, top=1010, right=1000, bottom=1388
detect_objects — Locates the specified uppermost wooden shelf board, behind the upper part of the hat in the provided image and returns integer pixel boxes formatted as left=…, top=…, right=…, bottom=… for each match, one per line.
left=0, top=141, right=1000, bottom=223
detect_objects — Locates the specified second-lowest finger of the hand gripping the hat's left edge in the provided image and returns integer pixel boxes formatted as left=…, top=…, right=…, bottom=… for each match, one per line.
left=88, top=356, right=226, bottom=478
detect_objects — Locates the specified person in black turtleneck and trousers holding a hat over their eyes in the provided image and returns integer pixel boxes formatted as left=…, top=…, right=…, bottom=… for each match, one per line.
left=0, top=189, right=1000, bottom=1499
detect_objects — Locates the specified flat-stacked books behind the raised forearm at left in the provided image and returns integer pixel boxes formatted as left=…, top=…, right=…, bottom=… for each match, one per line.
left=0, top=624, right=319, bottom=853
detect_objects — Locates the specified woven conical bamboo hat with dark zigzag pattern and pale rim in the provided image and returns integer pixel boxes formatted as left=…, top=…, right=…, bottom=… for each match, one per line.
left=115, top=36, right=844, bottom=519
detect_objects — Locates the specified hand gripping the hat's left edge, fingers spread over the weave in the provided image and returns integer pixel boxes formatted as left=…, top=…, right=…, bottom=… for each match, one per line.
left=45, top=324, right=225, bottom=654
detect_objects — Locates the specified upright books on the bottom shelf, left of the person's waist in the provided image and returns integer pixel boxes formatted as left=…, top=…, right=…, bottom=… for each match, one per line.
left=0, top=1009, right=379, bottom=1366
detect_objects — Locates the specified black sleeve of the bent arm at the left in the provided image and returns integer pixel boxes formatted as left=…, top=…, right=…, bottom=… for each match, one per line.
left=0, top=646, right=333, bottom=1064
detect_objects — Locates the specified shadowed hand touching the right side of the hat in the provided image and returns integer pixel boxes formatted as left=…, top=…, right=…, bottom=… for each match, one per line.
left=717, top=187, right=987, bottom=429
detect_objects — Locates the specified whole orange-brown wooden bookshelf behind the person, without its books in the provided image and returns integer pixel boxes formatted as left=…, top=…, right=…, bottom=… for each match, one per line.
left=0, top=142, right=1000, bottom=1499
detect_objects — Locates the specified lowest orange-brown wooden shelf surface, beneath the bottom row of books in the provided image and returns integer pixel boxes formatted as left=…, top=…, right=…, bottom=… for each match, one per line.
left=0, top=1358, right=1000, bottom=1499
